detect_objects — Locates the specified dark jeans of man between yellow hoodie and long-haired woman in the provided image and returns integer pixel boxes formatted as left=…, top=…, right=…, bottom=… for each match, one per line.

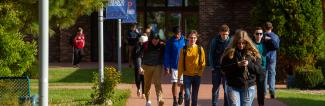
left=212, top=70, right=228, bottom=106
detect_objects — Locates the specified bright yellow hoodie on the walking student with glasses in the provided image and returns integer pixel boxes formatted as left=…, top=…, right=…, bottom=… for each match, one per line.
left=178, top=44, right=205, bottom=79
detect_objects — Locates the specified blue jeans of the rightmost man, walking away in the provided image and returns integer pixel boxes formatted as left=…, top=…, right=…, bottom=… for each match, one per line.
left=265, top=60, right=276, bottom=95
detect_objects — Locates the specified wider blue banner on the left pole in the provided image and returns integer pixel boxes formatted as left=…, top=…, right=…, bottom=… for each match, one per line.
left=106, top=0, right=128, bottom=19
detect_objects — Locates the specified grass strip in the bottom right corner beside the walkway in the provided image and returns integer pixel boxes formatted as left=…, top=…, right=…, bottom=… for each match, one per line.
left=277, top=89, right=325, bottom=106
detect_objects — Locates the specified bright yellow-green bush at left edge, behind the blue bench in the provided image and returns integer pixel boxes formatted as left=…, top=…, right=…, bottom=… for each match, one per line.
left=0, top=26, right=37, bottom=76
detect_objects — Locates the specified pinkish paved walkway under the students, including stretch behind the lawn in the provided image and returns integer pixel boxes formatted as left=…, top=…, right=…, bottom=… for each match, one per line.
left=50, top=62, right=286, bottom=106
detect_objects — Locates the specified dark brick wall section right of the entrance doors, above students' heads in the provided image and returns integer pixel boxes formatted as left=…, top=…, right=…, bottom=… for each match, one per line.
left=199, top=0, right=254, bottom=47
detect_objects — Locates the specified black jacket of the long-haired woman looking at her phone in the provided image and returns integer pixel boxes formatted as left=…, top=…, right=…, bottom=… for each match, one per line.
left=221, top=49, right=262, bottom=89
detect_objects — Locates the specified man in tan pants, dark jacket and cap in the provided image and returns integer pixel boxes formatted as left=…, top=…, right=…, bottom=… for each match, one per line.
left=140, top=36, right=164, bottom=106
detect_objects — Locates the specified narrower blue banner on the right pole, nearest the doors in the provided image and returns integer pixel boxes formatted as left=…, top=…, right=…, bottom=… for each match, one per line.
left=122, top=0, right=137, bottom=23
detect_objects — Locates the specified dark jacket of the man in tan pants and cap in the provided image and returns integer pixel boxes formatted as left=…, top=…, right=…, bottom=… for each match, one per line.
left=142, top=41, right=165, bottom=66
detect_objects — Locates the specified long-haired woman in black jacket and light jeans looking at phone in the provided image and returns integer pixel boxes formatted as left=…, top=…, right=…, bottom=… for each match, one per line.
left=221, top=30, right=261, bottom=106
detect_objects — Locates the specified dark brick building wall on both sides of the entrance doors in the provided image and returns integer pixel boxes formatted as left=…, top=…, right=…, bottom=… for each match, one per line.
left=50, top=0, right=254, bottom=62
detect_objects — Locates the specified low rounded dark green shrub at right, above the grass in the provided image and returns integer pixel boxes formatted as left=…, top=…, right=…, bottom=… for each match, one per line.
left=294, top=67, right=323, bottom=89
